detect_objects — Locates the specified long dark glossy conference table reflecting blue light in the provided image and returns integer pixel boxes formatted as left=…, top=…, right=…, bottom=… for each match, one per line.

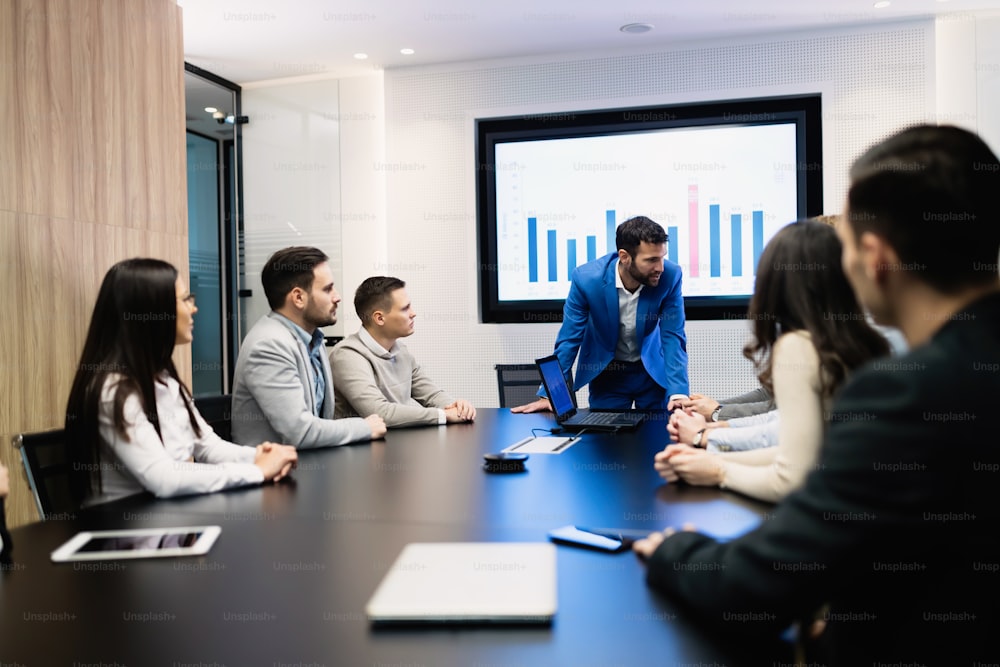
left=0, top=409, right=791, bottom=667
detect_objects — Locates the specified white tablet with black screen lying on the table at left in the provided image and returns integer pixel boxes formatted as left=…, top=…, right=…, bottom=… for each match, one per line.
left=51, top=526, right=222, bottom=563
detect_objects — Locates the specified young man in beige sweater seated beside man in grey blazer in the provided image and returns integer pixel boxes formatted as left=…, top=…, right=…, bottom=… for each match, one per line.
left=330, top=276, right=476, bottom=428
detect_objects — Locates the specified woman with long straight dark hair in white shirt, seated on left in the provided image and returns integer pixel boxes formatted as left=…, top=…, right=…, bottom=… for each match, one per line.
left=66, top=259, right=297, bottom=504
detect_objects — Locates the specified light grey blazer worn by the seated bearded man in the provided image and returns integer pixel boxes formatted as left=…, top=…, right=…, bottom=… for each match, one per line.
left=233, top=311, right=372, bottom=448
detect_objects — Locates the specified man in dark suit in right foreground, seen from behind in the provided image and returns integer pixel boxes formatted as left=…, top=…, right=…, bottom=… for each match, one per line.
left=635, top=126, right=1000, bottom=666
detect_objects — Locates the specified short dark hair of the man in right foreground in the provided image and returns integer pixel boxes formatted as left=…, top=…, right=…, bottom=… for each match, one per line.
left=847, top=125, right=1000, bottom=294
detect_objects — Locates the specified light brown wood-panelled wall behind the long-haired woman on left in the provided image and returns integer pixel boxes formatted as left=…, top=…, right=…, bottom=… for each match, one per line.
left=0, top=0, right=190, bottom=526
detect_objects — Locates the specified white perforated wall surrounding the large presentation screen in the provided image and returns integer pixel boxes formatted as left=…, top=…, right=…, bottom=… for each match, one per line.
left=382, top=22, right=935, bottom=406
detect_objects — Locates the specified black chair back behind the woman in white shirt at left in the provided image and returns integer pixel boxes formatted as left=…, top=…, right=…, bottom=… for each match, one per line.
left=13, top=429, right=79, bottom=521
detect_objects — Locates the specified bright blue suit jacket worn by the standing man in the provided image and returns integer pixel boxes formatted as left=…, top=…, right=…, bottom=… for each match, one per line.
left=555, top=252, right=689, bottom=396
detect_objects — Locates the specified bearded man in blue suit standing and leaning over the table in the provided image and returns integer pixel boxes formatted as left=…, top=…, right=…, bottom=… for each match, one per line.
left=511, top=216, right=688, bottom=412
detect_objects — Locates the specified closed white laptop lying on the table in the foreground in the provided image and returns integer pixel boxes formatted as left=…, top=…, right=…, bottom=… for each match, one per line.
left=365, top=542, right=556, bottom=625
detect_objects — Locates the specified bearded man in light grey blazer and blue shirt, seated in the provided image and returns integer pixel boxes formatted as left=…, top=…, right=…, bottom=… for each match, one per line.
left=233, top=246, right=385, bottom=448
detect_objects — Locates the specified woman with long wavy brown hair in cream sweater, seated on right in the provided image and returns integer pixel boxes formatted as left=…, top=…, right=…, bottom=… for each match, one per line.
left=654, top=221, right=889, bottom=502
